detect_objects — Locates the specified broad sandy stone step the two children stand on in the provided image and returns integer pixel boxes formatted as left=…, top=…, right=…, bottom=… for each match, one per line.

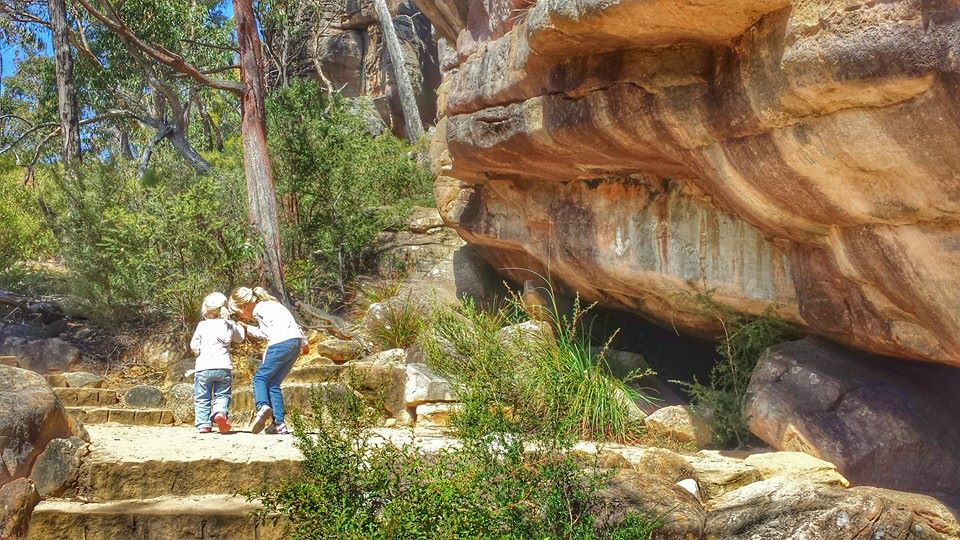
left=79, top=425, right=303, bottom=502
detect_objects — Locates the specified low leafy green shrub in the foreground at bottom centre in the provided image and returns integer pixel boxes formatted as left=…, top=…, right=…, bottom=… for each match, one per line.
left=250, top=384, right=658, bottom=540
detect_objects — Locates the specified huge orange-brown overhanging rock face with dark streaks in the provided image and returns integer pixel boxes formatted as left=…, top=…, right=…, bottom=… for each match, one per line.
left=418, top=0, right=960, bottom=365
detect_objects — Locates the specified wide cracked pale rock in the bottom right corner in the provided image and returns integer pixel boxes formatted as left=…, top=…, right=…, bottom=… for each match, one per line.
left=706, top=476, right=960, bottom=540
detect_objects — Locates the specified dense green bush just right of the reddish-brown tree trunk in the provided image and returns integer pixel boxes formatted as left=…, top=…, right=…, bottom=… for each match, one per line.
left=268, top=81, right=431, bottom=304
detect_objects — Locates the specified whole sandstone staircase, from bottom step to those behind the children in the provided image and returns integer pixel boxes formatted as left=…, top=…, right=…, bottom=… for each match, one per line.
left=28, top=356, right=464, bottom=540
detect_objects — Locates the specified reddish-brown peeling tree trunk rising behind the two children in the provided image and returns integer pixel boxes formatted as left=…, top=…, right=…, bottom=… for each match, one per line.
left=233, top=0, right=287, bottom=302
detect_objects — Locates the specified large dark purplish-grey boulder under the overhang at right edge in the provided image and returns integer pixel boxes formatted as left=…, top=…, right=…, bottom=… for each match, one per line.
left=746, top=338, right=960, bottom=492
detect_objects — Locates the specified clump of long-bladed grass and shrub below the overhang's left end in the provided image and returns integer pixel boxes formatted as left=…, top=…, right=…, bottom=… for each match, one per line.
left=424, top=291, right=648, bottom=441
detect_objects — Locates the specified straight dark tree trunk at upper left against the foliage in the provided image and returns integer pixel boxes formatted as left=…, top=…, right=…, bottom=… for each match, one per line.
left=47, top=0, right=80, bottom=165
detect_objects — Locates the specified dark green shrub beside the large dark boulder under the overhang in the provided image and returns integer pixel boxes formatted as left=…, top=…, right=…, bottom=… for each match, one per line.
left=677, top=300, right=789, bottom=447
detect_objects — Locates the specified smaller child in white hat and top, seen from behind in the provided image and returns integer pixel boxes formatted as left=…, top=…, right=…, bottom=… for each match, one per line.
left=190, top=292, right=244, bottom=433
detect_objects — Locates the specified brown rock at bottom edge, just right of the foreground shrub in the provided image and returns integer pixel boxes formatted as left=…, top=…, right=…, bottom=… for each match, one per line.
left=598, top=469, right=706, bottom=540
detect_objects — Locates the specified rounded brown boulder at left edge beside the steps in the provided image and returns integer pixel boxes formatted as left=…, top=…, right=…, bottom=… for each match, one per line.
left=0, top=365, right=73, bottom=485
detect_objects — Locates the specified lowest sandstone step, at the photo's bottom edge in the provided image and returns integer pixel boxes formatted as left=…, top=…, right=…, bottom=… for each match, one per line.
left=27, top=495, right=284, bottom=540
